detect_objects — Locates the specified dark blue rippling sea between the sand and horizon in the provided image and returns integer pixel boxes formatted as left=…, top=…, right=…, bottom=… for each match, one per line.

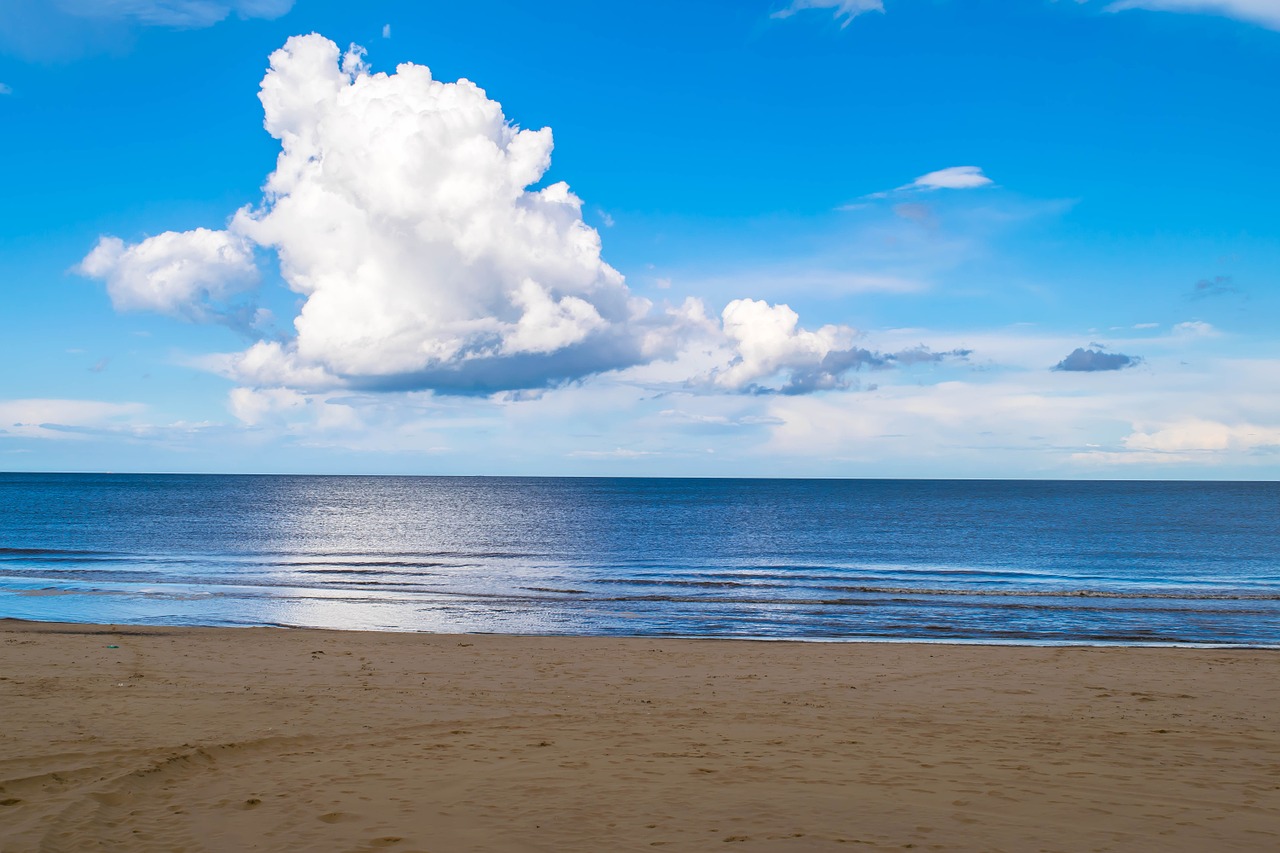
left=0, top=474, right=1280, bottom=644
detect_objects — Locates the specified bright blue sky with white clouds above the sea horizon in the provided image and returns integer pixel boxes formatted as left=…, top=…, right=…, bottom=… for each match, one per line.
left=0, top=0, right=1280, bottom=479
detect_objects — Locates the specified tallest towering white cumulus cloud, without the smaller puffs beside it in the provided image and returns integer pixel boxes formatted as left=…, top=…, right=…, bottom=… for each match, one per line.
left=232, top=36, right=686, bottom=389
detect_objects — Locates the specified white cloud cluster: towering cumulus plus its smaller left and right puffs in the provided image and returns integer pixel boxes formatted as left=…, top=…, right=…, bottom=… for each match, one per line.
left=78, top=33, right=962, bottom=399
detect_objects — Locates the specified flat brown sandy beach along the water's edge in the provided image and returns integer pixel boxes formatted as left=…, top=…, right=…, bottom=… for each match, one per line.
left=0, top=620, right=1280, bottom=853
